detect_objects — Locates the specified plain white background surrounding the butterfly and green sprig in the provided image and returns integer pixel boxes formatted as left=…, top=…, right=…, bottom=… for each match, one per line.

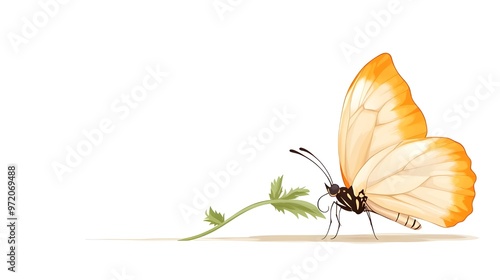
left=0, top=0, right=500, bottom=280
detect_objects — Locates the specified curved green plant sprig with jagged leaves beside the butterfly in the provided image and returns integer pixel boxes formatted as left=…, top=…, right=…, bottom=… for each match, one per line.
left=180, top=176, right=325, bottom=241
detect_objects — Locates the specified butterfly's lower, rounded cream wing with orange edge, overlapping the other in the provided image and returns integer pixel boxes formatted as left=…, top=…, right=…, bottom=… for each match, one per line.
left=353, top=137, right=476, bottom=227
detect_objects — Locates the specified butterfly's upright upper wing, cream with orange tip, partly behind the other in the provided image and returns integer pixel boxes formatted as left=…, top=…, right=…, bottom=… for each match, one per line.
left=338, top=53, right=427, bottom=188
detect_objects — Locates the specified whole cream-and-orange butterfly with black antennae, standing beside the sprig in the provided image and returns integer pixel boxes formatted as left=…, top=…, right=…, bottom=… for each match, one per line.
left=290, top=53, right=476, bottom=238
